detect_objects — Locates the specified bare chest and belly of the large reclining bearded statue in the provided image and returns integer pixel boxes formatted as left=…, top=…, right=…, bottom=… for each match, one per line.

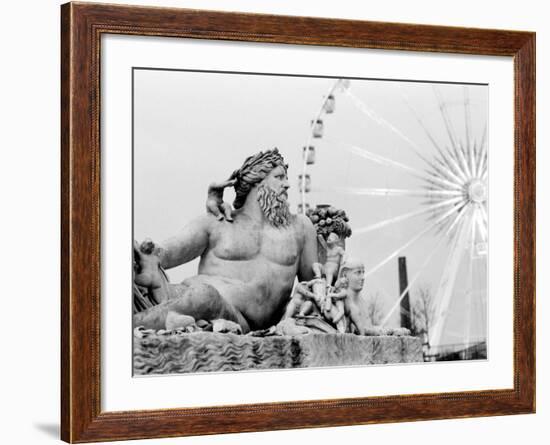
left=186, top=215, right=305, bottom=328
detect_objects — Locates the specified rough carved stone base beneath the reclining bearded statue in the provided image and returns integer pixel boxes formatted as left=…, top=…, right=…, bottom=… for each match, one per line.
left=134, top=331, right=422, bottom=375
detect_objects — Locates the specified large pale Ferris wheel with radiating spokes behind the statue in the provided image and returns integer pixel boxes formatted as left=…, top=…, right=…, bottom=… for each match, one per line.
left=298, top=79, right=488, bottom=351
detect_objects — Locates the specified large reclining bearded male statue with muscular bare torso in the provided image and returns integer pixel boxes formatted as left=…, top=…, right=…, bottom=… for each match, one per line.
left=134, top=149, right=317, bottom=333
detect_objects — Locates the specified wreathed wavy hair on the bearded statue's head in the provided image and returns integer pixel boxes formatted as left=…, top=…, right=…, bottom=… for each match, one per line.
left=230, top=148, right=288, bottom=209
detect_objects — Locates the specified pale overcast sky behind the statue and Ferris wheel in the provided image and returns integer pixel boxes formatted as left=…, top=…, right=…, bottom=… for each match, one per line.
left=134, top=70, right=488, bottom=343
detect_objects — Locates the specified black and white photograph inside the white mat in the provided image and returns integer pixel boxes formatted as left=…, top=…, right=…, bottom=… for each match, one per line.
left=130, top=67, right=489, bottom=376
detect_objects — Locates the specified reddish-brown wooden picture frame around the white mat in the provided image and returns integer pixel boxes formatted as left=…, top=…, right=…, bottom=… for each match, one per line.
left=61, top=3, right=535, bottom=443
